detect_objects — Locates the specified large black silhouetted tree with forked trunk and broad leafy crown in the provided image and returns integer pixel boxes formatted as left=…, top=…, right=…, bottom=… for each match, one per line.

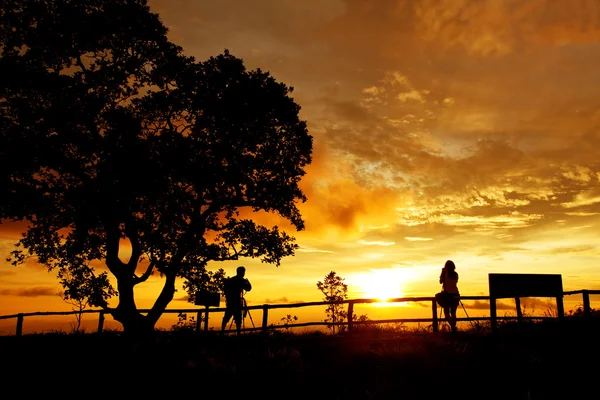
left=0, top=0, right=312, bottom=333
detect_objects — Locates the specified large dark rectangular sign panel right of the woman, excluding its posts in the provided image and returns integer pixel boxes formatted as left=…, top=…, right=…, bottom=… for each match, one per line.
left=489, top=274, right=563, bottom=299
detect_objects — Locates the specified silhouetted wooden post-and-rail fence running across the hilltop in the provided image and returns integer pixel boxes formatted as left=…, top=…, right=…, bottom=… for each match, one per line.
left=0, top=289, right=600, bottom=336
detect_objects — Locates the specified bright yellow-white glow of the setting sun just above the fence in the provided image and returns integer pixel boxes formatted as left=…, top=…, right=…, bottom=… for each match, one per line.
left=355, top=268, right=411, bottom=302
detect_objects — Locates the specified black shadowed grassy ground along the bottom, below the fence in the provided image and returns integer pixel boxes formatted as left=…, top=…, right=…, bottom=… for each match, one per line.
left=0, top=318, right=600, bottom=400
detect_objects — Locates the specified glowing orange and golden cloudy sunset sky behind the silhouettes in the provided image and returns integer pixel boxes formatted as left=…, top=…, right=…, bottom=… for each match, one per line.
left=0, top=0, right=600, bottom=332
